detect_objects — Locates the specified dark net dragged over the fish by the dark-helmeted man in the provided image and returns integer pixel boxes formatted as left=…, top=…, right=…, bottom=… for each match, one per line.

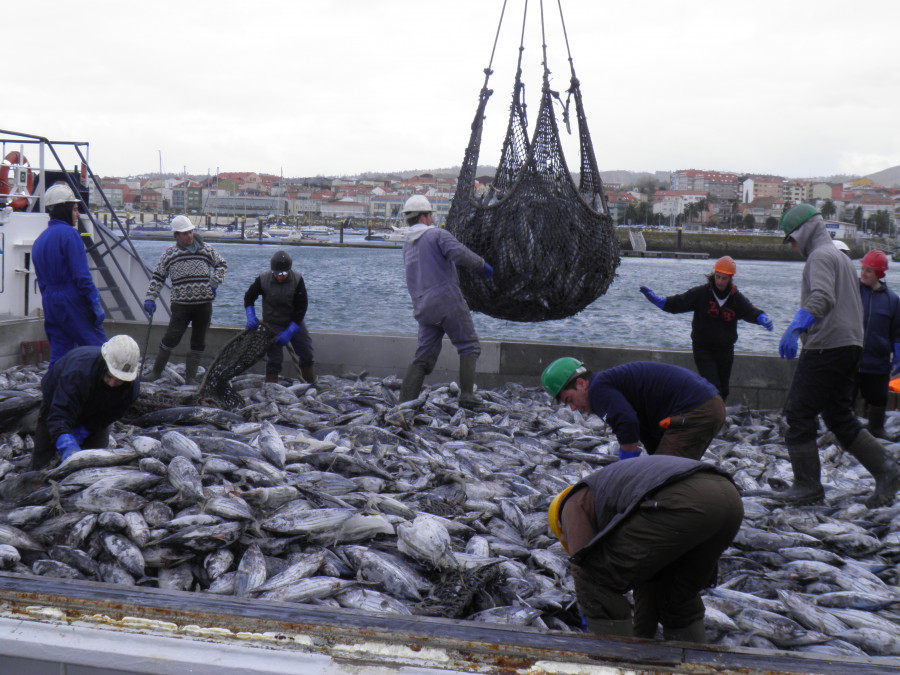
left=197, top=324, right=277, bottom=410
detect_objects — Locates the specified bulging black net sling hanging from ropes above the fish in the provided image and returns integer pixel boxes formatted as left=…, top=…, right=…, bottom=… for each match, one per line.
left=446, top=0, right=619, bottom=322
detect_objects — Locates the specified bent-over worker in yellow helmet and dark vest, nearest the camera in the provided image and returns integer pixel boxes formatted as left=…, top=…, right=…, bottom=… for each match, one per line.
left=548, top=455, right=744, bottom=643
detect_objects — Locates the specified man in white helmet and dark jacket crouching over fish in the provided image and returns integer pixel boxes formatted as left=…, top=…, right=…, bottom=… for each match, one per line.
left=31, top=335, right=141, bottom=470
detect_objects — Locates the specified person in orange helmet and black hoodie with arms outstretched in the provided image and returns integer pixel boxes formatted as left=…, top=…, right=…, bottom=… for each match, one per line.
left=640, top=255, right=774, bottom=401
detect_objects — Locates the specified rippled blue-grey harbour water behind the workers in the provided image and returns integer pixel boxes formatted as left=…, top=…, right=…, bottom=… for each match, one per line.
left=134, top=240, right=900, bottom=354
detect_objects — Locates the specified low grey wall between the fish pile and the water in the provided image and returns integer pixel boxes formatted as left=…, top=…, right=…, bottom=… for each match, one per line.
left=88, top=321, right=794, bottom=409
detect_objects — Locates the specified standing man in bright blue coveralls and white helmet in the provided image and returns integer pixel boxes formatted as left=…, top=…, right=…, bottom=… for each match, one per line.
left=31, top=183, right=106, bottom=365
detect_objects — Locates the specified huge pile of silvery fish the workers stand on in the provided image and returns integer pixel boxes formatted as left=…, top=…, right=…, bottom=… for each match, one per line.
left=0, top=365, right=900, bottom=656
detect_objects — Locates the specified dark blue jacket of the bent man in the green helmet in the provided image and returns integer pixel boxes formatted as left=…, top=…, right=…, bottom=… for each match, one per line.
left=588, top=361, right=719, bottom=453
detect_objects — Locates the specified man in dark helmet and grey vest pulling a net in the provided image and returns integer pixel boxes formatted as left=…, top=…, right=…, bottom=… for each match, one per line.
left=244, top=251, right=316, bottom=384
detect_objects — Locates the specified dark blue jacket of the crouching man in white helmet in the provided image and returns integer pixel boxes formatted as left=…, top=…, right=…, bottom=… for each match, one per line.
left=41, top=346, right=141, bottom=447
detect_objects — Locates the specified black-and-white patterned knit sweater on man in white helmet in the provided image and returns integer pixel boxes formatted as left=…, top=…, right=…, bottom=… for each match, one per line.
left=147, top=242, right=228, bottom=305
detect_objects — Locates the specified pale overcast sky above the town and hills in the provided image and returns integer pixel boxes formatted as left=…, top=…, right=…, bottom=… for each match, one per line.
left=10, top=0, right=900, bottom=177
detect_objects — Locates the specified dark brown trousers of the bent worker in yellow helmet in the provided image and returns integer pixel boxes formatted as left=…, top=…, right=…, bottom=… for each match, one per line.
left=561, top=472, right=744, bottom=638
